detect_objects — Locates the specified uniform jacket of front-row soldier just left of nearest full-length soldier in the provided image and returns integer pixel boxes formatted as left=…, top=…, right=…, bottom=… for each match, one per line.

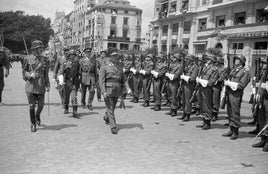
left=201, top=64, right=219, bottom=86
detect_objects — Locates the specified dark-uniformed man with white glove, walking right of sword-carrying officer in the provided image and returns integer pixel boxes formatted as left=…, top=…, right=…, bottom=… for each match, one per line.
left=59, top=50, right=80, bottom=118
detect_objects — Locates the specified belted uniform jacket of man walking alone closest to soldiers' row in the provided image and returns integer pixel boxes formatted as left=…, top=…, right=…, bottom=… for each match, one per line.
left=99, top=62, right=125, bottom=97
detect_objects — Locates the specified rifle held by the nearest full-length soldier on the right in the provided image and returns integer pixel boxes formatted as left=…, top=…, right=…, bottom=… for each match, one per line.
left=220, top=47, right=236, bottom=109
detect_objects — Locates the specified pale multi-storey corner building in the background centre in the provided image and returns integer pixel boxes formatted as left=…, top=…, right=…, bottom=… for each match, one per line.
left=85, top=0, right=142, bottom=52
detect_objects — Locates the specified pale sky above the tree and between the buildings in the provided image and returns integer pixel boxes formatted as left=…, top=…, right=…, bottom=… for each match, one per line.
left=0, top=0, right=154, bottom=36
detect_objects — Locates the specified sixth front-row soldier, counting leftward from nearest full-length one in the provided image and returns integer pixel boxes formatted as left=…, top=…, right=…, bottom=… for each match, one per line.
left=140, top=54, right=153, bottom=107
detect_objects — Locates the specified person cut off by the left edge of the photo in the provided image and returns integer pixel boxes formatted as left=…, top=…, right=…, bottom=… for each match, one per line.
left=0, top=48, right=10, bottom=105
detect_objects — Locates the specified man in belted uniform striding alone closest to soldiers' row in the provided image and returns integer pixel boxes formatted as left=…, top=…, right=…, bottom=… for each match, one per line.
left=99, top=52, right=125, bottom=134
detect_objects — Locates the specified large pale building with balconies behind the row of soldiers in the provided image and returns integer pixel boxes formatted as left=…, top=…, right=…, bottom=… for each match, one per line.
left=150, top=0, right=268, bottom=66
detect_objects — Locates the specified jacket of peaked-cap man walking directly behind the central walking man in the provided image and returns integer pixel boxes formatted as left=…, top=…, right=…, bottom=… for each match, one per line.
left=80, top=57, right=97, bottom=85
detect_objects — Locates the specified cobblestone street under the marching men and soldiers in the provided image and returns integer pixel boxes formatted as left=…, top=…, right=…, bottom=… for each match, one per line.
left=0, top=63, right=268, bottom=174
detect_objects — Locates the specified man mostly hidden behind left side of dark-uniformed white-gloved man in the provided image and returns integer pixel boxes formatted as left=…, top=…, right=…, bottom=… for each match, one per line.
left=53, top=47, right=69, bottom=107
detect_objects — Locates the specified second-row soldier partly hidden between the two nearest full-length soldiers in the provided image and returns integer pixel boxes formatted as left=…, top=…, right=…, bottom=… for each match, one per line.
left=212, top=57, right=226, bottom=122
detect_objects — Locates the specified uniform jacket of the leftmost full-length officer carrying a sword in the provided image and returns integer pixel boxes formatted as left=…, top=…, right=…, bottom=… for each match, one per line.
left=22, top=55, right=50, bottom=94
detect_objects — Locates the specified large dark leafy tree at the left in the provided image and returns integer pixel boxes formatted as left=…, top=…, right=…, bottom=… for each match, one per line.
left=0, top=11, right=53, bottom=53
